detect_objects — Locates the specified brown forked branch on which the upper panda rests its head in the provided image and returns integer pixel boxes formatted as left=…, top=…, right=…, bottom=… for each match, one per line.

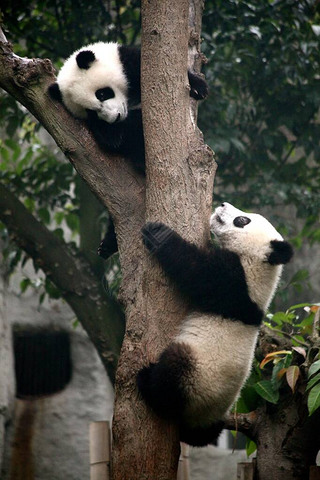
left=0, top=33, right=145, bottom=340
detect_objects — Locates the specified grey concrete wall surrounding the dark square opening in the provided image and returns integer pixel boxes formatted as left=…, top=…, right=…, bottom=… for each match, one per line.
left=0, top=262, right=113, bottom=480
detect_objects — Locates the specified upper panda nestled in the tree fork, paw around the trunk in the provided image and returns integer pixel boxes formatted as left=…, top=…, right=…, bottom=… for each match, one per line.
left=49, top=42, right=208, bottom=172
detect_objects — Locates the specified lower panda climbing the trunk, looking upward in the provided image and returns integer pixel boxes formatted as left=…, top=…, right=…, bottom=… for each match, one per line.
left=137, top=203, right=293, bottom=446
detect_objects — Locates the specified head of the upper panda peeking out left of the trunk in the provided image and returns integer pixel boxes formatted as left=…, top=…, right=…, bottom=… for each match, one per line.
left=49, top=42, right=128, bottom=123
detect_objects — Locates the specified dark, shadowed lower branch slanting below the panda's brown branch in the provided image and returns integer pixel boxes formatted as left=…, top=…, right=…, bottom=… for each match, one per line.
left=0, top=184, right=124, bottom=382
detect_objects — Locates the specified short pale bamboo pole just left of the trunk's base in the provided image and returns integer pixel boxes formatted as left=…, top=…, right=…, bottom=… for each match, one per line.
left=89, top=421, right=110, bottom=480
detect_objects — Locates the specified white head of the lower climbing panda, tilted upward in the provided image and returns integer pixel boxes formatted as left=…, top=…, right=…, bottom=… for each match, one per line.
left=210, top=202, right=293, bottom=265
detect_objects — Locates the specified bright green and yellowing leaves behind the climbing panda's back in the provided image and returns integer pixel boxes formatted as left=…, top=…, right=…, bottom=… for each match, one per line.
left=236, top=304, right=320, bottom=426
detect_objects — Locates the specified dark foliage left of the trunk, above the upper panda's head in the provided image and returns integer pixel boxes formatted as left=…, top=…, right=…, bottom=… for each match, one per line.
left=1, top=0, right=140, bottom=61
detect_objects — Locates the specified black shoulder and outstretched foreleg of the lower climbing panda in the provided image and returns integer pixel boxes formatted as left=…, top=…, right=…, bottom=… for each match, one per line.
left=142, top=223, right=263, bottom=325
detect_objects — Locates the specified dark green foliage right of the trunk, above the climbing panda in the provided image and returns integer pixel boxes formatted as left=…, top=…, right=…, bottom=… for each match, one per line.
left=199, top=0, right=320, bottom=223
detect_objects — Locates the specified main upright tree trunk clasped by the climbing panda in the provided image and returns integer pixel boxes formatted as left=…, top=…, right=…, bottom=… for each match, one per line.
left=113, top=0, right=215, bottom=480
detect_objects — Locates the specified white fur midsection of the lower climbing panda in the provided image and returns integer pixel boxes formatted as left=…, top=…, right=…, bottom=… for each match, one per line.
left=175, top=313, right=258, bottom=426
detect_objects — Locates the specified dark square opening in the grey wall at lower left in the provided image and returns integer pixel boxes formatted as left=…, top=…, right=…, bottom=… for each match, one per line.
left=13, top=329, right=72, bottom=398
